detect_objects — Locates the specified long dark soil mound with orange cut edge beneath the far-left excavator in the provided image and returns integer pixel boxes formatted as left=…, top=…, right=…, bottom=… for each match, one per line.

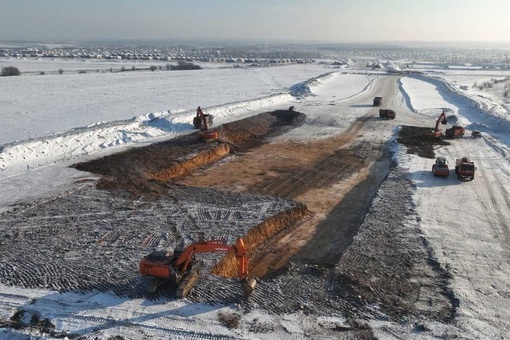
left=73, top=110, right=306, bottom=195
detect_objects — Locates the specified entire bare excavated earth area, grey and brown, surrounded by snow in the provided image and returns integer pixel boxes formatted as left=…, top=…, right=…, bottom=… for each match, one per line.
left=0, top=99, right=456, bottom=339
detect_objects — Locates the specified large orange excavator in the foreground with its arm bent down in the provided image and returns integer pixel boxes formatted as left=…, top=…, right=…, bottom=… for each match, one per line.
left=140, top=238, right=256, bottom=298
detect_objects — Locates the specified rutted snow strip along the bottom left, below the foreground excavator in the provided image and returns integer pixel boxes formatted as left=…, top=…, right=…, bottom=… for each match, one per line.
left=0, top=302, right=243, bottom=340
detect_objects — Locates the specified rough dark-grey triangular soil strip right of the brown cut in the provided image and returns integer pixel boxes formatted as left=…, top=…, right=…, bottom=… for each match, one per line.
left=338, top=168, right=455, bottom=322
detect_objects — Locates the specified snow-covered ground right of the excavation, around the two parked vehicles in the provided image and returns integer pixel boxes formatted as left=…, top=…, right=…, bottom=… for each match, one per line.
left=399, top=73, right=510, bottom=339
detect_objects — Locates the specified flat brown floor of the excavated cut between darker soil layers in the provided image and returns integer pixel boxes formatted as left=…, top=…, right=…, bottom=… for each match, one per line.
left=178, top=115, right=389, bottom=277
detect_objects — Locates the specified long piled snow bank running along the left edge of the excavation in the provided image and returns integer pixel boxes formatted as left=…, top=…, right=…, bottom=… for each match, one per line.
left=0, top=72, right=370, bottom=178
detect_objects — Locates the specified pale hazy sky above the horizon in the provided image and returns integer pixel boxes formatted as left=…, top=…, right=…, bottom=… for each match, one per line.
left=0, top=0, right=510, bottom=43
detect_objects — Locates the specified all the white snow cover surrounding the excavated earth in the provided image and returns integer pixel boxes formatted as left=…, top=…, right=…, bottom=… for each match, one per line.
left=0, top=57, right=510, bottom=339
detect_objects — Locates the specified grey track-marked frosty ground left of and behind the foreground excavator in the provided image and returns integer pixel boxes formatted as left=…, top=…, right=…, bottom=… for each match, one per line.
left=0, top=185, right=295, bottom=297
